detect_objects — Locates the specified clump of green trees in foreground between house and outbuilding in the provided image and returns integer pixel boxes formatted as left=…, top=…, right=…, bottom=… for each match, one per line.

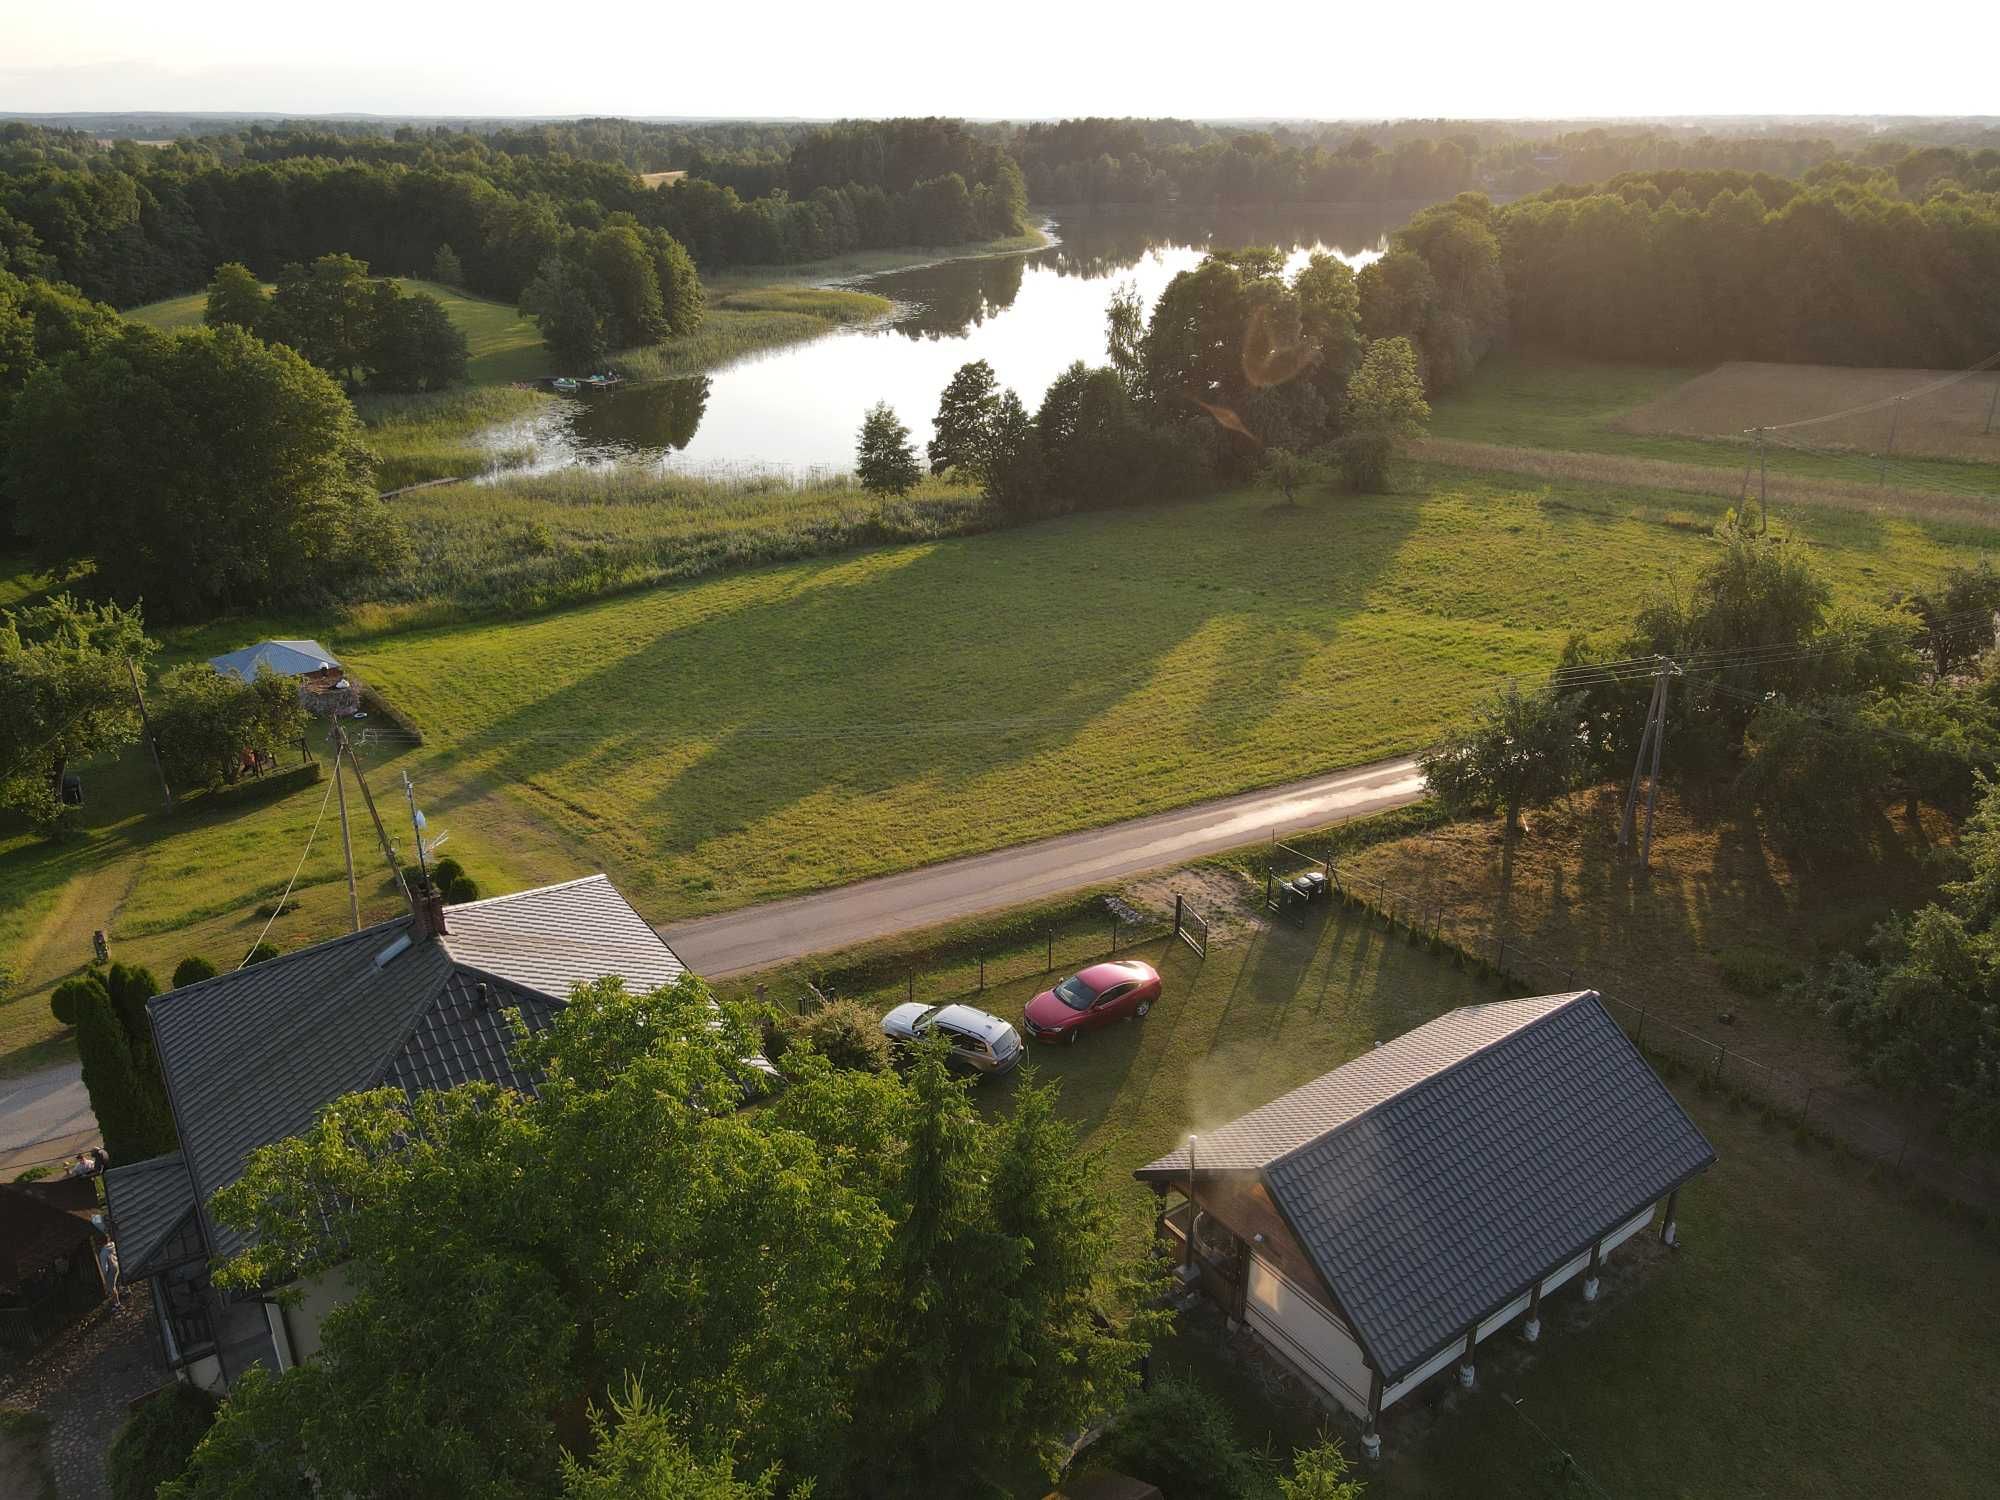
left=162, top=980, right=1154, bottom=1500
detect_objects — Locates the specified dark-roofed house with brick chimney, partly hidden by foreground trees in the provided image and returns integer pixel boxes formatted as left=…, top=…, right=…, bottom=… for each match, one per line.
left=104, top=876, right=686, bottom=1388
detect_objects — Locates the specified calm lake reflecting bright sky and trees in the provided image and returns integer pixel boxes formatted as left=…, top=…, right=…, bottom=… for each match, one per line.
left=486, top=204, right=1416, bottom=478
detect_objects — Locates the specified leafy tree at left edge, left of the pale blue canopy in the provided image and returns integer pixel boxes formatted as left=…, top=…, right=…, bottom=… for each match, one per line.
left=0, top=594, right=158, bottom=832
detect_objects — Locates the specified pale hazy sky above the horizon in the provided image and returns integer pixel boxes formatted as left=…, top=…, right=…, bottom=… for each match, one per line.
left=0, top=0, right=2000, bottom=120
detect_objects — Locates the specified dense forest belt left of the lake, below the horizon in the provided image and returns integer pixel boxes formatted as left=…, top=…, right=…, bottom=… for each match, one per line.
left=0, top=120, right=1026, bottom=306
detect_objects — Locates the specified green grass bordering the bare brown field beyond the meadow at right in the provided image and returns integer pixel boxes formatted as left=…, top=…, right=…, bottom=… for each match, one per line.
left=1430, top=350, right=2000, bottom=494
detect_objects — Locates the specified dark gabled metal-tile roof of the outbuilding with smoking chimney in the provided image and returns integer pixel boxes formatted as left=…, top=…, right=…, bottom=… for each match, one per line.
left=1138, top=990, right=1716, bottom=1380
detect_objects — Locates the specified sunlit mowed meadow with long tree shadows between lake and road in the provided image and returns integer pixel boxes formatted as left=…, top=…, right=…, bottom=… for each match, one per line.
left=344, top=464, right=2000, bottom=920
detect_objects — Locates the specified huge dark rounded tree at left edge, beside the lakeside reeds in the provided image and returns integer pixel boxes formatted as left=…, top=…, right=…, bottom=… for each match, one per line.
left=6, top=328, right=406, bottom=618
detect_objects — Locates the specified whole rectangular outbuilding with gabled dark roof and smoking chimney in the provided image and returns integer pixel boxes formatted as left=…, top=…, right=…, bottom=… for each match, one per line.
left=1136, top=990, right=1716, bottom=1454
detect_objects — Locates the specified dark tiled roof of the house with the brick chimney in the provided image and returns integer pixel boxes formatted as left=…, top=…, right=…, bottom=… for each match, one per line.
left=148, top=876, right=686, bottom=1256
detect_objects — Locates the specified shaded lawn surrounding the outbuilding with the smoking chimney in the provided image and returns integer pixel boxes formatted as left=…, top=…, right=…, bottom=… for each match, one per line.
left=788, top=912, right=2000, bottom=1500
